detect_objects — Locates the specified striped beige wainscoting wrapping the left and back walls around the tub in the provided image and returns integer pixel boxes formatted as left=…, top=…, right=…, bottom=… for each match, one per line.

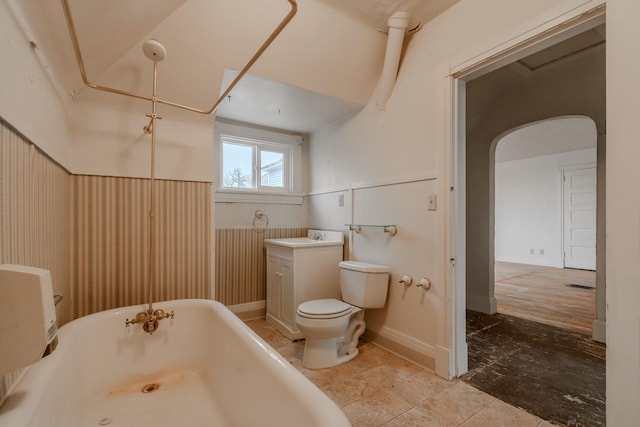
left=0, top=121, right=212, bottom=398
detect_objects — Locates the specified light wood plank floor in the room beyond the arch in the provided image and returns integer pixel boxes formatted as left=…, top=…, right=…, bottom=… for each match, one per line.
left=494, top=262, right=596, bottom=335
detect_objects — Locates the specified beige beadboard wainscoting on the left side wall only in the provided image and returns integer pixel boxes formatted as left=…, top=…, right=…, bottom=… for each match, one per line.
left=0, top=119, right=72, bottom=401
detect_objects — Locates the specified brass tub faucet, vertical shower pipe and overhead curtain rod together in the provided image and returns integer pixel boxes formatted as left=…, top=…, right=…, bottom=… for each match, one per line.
left=61, top=0, right=298, bottom=334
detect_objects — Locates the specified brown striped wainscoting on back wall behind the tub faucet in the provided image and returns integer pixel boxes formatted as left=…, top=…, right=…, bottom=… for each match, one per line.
left=72, top=175, right=211, bottom=317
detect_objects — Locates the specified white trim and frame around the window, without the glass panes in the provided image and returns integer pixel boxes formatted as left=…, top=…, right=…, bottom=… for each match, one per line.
left=214, top=120, right=304, bottom=204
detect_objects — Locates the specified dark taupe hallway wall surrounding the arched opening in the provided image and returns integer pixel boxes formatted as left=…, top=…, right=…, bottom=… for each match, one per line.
left=457, top=27, right=606, bottom=340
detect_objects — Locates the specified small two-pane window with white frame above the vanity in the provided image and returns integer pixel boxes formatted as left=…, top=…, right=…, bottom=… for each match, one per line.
left=215, top=122, right=302, bottom=204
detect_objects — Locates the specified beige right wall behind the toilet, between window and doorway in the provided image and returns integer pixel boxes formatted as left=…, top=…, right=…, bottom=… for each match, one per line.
left=309, top=0, right=596, bottom=376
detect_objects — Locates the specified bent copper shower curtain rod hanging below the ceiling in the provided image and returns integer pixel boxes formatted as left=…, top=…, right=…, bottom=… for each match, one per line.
left=61, top=0, right=298, bottom=114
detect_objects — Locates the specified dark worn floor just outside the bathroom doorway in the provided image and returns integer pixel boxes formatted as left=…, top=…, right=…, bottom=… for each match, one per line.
left=462, top=310, right=606, bottom=427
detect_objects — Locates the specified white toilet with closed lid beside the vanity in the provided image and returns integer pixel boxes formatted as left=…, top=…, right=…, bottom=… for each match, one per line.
left=296, top=261, right=389, bottom=369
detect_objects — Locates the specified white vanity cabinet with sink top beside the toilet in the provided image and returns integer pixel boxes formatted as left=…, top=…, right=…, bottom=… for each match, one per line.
left=265, top=232, right=343, bottom=340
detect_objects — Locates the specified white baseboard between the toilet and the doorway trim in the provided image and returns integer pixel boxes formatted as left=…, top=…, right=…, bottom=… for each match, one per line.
left=364, top=325, right=438, bottom=378
